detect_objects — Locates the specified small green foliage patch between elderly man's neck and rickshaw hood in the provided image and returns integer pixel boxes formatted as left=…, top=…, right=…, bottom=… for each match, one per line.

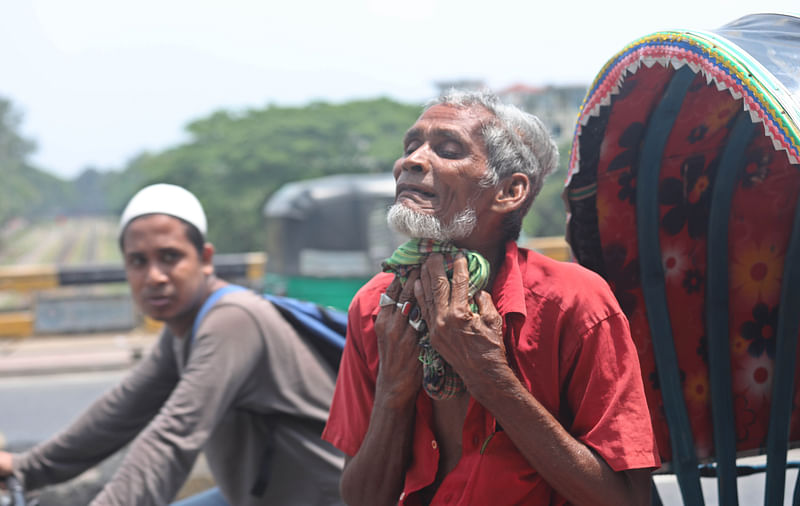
left=522, top=142, right=570, bottom=237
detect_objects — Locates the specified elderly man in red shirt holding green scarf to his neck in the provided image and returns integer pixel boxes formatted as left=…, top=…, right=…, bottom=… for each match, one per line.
left=323, top=92, right=659, bottom=506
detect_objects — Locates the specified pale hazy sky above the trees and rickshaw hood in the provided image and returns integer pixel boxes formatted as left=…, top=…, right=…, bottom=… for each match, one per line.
left=0, top=0, right=800, bottom=177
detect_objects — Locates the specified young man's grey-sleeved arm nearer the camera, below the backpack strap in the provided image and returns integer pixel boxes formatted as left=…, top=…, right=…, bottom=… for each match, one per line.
left=92, top=304, right=264, bottom=505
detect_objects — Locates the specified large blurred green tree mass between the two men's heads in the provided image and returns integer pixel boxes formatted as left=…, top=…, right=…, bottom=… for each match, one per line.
left=112, top=99, right=421, bottom=252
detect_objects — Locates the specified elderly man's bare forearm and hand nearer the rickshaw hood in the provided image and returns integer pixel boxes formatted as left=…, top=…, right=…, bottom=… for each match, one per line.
left=415, top=255, right=650, bottom=505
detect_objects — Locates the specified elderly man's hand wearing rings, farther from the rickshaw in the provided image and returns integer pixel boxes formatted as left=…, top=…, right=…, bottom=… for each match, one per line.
left=375, top=269, right=422, bottom=402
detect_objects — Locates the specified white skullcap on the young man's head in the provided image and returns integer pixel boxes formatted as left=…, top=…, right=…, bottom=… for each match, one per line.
left=119, top=183, right=206, bottom=237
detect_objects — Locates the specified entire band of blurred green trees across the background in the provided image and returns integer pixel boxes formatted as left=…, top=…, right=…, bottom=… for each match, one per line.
left=0, top=89, right=569, bottom=252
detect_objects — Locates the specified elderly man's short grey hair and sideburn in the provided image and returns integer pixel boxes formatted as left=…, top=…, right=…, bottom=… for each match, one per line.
left=425, top=89, right=558, bottom=239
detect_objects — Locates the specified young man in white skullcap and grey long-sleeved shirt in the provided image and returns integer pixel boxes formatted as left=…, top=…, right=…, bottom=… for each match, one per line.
left=0, top=184, right=344, bottom=506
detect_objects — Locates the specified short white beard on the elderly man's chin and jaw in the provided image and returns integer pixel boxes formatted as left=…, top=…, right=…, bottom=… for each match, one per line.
left=386, top=203, right=478, bottom=242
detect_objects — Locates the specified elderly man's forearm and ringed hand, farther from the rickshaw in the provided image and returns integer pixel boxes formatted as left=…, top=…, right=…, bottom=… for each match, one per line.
left=341, top=271, right=422, bottom=506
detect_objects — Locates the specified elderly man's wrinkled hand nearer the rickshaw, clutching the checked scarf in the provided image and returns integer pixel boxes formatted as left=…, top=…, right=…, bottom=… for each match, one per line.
left=414, top=254, right=508, bottom=390
